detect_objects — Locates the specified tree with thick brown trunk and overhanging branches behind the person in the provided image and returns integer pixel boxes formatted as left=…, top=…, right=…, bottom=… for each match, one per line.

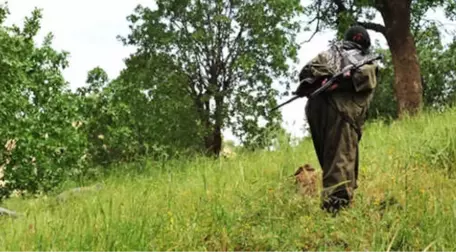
left=307, top=0, right=455, bottom=118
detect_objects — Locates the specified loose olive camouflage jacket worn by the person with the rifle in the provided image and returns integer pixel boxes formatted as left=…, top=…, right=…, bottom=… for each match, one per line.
left=299, top=41, right=378, bottom=131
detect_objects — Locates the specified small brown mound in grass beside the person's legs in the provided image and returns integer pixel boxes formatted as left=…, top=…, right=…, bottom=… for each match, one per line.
left=294, top=164, right=317, bottom=196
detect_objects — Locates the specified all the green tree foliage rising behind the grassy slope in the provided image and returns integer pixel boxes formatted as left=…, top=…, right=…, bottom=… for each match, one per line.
left=0, top=0, right=456, bottom=211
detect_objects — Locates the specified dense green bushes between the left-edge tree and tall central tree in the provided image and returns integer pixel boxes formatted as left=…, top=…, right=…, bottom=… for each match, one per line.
left=78, top=64, right=205, bottom=165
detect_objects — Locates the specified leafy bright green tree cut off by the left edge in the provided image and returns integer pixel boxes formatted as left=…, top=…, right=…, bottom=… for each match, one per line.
left=0, top=9, right=85, bottom=199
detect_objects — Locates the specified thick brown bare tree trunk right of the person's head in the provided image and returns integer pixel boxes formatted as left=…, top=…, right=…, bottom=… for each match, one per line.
left=381, top=0, right=423, bottom=118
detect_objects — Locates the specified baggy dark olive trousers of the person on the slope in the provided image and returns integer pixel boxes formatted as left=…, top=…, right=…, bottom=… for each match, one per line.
left=305, top=94, right=361, bottom=207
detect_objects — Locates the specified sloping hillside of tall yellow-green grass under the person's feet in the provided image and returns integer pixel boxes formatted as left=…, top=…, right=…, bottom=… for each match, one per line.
left=0, top=110, right=456, bottom=251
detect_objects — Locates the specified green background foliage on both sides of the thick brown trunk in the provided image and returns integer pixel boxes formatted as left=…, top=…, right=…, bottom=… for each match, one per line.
left=369, top=22, right=456, bottom=119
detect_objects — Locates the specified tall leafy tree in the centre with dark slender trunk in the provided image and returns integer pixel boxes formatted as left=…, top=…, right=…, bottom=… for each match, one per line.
left=121, top=0, right=302, bottom=155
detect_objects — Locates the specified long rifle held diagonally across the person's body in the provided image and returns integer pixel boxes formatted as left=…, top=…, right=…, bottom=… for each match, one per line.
left=270, top=54, right=383, bottom=112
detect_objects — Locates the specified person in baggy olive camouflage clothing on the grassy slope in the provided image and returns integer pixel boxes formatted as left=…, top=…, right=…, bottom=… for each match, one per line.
left=295, top=26, right=378, bottom=215
